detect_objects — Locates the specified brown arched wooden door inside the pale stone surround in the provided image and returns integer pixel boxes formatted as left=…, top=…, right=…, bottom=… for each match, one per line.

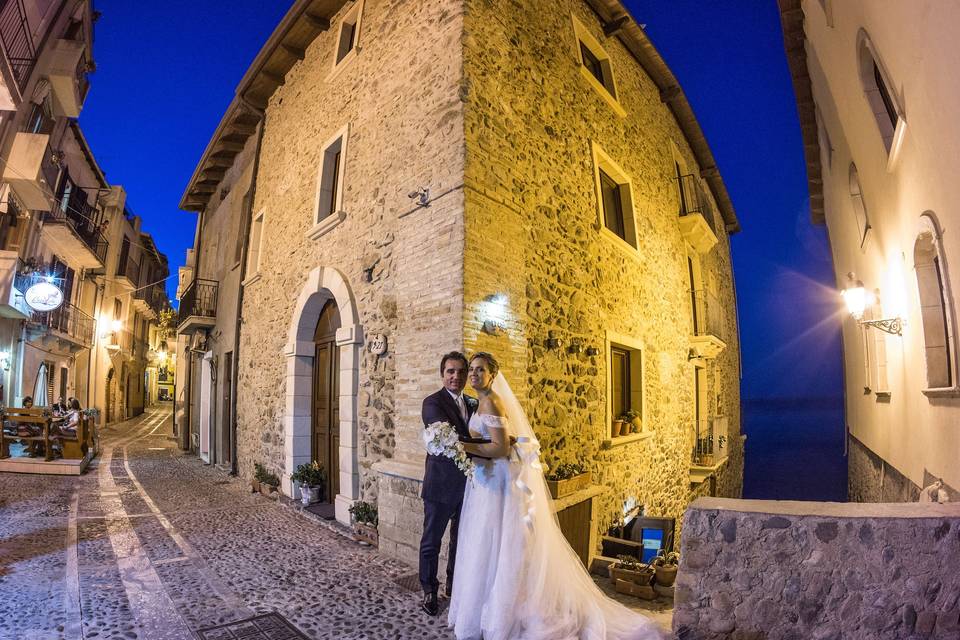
left=312, top=300, right=340, bottom=502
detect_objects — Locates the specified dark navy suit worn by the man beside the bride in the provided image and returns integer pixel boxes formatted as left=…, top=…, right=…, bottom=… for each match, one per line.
left=420, top=389, right=477, bottom=593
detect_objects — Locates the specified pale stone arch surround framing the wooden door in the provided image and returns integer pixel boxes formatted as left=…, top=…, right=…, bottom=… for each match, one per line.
left=283, top=267, right=363, bottom=524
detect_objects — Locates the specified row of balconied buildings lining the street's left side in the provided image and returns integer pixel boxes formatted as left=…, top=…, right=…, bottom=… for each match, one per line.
left=0, top=0, right=167, bottom=420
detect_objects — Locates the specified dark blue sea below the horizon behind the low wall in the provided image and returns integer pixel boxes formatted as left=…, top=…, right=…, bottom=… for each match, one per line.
left=742, top=398, right=847, bottom=502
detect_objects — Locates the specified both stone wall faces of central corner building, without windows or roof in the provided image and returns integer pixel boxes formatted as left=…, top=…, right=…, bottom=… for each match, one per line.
left=218, top=0, right=743, bottom=562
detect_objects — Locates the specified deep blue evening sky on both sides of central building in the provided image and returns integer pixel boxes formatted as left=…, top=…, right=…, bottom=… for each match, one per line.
left=80, top=0, right=842, bottom=398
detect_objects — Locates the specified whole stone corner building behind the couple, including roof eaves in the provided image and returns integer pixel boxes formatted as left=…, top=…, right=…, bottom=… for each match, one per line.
left=179, top=0, right=743, bottom=561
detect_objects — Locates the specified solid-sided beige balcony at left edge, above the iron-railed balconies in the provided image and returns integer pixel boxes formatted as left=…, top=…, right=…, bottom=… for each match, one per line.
left=3, top=131, right=60, bottom=211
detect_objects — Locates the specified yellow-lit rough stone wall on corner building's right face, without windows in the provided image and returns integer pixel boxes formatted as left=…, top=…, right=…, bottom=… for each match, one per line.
left=464, top=0, right=742, bottom=544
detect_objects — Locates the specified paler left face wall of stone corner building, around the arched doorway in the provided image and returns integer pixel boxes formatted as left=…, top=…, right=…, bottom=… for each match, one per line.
left=238, top=0, right=463, bottom=498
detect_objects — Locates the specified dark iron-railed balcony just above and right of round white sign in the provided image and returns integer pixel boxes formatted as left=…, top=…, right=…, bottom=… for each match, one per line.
left=42, top=189, right=107, bottom=269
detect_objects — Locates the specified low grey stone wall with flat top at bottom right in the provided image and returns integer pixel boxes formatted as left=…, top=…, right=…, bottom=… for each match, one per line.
left=673, top=498, right=960, bottom=640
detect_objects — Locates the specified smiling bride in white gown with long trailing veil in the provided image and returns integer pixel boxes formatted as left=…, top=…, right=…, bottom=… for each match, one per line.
left=448, top=353, right=663, bottom=640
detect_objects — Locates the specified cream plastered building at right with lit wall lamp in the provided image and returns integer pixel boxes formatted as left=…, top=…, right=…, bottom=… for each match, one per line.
left=780, top=0, right=960, bottom=502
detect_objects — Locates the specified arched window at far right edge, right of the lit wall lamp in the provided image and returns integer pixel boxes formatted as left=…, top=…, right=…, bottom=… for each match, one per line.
left=913, top=214, right=956, bottom=389
